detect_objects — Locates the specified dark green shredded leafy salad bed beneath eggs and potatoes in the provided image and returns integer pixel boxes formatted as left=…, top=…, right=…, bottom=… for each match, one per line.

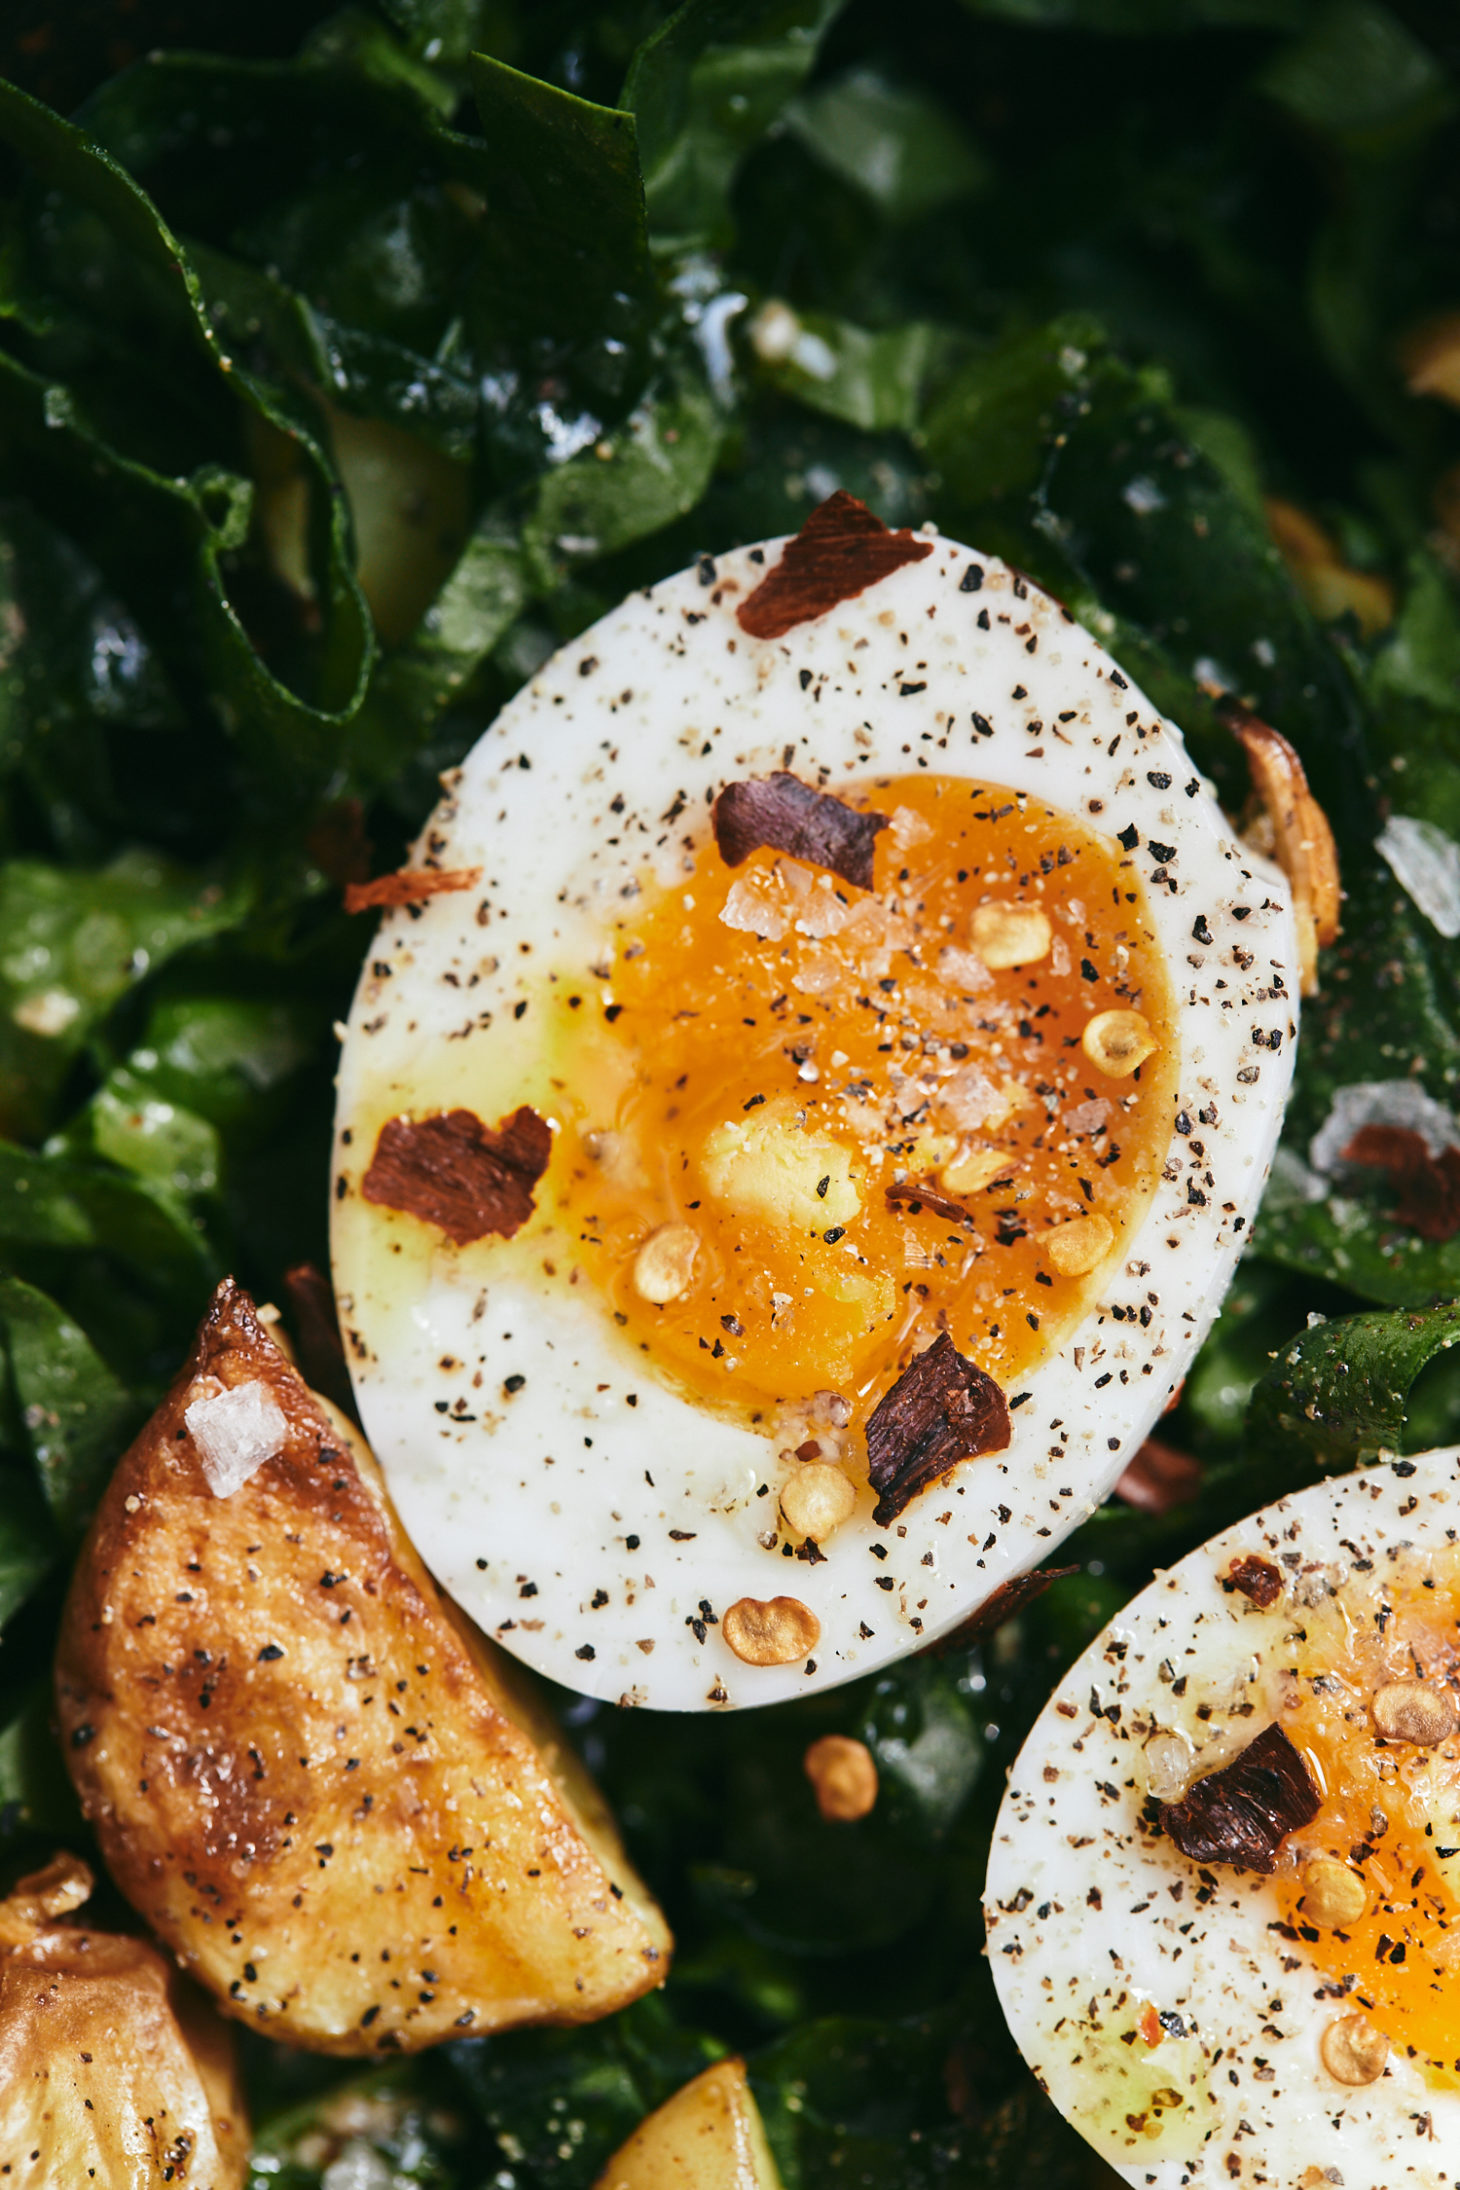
left=0, top=0, right=1460, bottom=2190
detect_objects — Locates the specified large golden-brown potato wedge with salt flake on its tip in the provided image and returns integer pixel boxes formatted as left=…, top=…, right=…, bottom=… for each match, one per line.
left=57, top=1281, right=670, bottom=2054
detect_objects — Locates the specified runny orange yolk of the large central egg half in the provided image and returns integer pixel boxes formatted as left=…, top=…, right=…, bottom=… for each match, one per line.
left=538, top=775, right=1178, bottom=1419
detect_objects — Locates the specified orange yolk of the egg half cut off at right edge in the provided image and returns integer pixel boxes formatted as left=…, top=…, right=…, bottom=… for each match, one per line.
left=1276, top=1551, right=1460, bottom=2089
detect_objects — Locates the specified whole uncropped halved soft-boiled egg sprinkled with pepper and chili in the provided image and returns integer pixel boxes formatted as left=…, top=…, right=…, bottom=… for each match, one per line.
left=333, top=495, right=1298, bottom=1710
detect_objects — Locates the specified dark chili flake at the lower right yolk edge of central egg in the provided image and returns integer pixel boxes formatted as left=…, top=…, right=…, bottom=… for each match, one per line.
left=867, top=1332, right=1013, bottom=1529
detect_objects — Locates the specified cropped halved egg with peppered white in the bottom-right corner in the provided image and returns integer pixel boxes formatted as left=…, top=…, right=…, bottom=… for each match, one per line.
left=987, top=1448, right=1460, bottom=2190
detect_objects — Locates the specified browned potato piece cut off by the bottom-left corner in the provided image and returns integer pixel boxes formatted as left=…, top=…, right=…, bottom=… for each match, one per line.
left=0, top=1857, right=250, bottom=2190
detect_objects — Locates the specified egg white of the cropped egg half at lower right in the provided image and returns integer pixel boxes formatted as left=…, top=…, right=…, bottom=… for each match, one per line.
left=985, top=1445, right=1460, bottom=2190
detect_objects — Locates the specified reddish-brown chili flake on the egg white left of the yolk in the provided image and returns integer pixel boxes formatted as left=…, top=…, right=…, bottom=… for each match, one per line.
left=361, top=1104, right=552, bottom=1246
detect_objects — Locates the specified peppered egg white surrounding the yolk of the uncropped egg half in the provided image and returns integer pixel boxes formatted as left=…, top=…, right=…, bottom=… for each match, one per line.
left=331, top=525, right=1298, bottom=1710
